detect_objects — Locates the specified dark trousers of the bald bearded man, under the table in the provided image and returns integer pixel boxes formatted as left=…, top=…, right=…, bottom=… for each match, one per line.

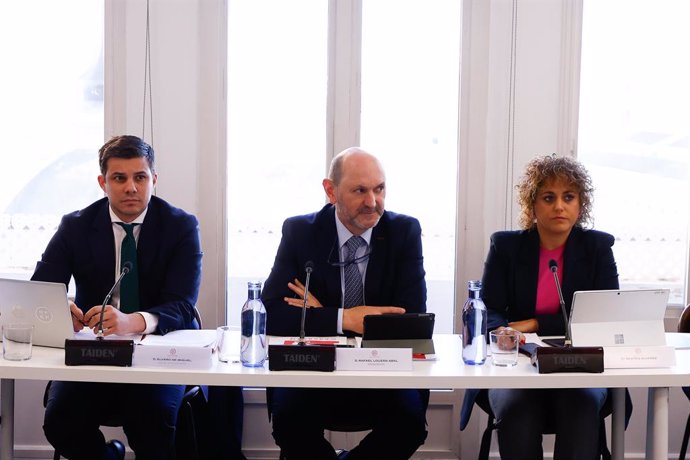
left=270, top=388, right=428, bottom=460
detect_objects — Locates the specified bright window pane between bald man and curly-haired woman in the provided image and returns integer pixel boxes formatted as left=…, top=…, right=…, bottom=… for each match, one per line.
left=361, top=0, right=461, bottom=333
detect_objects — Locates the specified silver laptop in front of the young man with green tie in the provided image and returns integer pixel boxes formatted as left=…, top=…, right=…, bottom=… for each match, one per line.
left=0, top=278, right=74, bottom=348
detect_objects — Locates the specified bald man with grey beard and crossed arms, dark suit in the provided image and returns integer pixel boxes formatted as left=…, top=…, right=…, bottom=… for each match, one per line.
left=262, top=148, right=428, bottom=460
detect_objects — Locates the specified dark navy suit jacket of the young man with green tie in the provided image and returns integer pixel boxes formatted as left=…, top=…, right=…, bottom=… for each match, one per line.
left=32, top=196, right=202, bottom=334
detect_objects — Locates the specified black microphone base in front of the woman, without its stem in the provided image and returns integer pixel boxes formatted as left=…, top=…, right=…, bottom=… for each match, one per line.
left=532, top=347, right=604, bottom=374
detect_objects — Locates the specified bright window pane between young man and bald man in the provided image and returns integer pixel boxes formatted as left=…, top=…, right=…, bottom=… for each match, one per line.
left=227, top=0, right=328, bottom=324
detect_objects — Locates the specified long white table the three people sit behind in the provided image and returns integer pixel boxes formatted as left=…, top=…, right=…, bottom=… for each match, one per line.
left=0, top=334, right=690, bottom=460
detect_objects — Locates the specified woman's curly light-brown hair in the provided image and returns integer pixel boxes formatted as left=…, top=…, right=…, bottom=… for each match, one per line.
left=515, top=153, right=594, bottom=230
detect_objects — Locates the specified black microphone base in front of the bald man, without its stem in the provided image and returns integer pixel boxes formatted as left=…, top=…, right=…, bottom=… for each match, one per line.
left=268, top=344, right=335, bottom=372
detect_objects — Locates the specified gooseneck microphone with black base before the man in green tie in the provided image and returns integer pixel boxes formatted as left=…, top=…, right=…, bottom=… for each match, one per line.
left=65, top=261, right=134, bottom=366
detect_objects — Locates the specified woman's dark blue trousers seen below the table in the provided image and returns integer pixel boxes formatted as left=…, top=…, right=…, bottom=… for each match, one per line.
left=489, top=388, right=607, bottom=460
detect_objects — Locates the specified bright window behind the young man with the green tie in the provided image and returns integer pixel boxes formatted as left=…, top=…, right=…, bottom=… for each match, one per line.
left=0, top=0, right=104, bottom=277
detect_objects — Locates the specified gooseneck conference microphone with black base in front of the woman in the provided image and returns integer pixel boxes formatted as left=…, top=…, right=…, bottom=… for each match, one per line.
left=532, top=259, right=604, bottom=374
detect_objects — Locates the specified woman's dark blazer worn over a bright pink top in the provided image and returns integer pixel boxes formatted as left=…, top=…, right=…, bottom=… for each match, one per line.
left=460, top=227, right=620, bottom=429
